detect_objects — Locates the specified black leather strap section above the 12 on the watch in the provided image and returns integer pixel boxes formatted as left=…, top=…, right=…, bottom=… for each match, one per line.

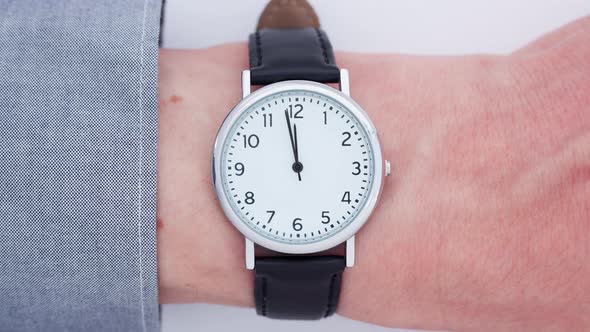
left=248, top=28, right=340, bottom=85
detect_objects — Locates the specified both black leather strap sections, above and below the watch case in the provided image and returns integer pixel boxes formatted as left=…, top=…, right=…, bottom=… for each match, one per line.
left=249, top=22, right=346, bottom=319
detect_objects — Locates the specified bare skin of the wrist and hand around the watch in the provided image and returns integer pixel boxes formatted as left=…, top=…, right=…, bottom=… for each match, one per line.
left=157, top=18, right=590, bottom=331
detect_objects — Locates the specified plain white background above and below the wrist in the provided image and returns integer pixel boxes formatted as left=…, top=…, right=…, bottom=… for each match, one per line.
left=162, top=0, right=590, bottom=332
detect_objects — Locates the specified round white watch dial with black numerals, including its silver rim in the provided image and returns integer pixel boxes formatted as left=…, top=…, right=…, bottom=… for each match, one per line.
left=214, top=82, right=381, bottom=252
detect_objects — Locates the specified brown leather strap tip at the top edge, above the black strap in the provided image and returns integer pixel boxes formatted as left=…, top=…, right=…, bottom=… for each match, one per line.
left=256, top=0, right=320, bottom=30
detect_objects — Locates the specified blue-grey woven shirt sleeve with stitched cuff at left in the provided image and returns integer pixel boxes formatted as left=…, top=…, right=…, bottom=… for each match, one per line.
left=0, top=0, right=161, bottom=332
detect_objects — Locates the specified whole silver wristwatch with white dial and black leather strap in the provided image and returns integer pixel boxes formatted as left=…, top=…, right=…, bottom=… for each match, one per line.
left=212, top=0, right=390, bottom=319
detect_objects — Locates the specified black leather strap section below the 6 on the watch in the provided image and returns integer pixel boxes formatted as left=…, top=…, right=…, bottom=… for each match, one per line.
left=254, top=256, right=346, bottom=319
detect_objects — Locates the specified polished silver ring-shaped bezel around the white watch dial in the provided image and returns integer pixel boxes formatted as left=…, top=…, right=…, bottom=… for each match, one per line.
left=212, top=80, right=384, bottom=254
